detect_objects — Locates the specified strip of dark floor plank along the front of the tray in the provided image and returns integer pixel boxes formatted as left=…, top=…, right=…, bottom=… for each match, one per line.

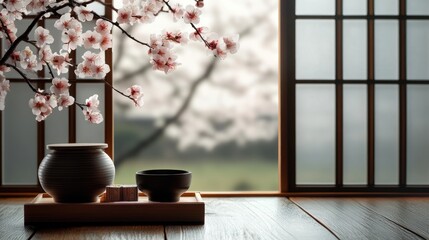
left=31, top=226, right=164, bottom=240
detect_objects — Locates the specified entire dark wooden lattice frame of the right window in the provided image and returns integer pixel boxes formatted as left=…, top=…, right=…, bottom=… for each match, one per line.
left=279, top=0, right=429, bottom=195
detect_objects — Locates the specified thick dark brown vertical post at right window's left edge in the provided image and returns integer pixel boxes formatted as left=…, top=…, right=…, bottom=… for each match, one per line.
left=279, top=1, right=296, bottom=193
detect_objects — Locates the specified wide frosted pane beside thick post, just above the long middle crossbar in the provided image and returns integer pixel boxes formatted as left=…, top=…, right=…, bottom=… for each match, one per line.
left=296, top=20, right=335, bottom=79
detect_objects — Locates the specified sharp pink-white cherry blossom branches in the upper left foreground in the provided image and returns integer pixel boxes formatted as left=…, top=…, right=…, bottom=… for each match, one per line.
left=0, top=0, right=238, bottom=124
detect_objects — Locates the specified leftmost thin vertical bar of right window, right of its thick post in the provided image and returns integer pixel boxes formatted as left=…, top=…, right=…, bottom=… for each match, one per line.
left=335, top=0, right=343, bottom=187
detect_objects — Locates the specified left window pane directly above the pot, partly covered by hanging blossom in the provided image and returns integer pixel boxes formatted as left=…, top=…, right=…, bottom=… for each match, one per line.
left=76, top=83, right=106, bottom=143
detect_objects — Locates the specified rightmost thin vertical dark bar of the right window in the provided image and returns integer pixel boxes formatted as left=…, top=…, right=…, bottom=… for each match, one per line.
left=399, top=0, right=407, bottom=187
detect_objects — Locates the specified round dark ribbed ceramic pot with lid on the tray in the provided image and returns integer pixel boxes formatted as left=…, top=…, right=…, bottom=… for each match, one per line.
left=38, top=143, right=115, bottom=203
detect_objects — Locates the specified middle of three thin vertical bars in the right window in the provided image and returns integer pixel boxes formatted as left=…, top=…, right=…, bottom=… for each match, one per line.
left=367, top=0, right=375, bottom=187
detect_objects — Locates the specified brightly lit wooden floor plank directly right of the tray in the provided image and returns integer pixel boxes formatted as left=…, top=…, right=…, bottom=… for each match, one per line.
left=166, top=198, right=335, bottom=240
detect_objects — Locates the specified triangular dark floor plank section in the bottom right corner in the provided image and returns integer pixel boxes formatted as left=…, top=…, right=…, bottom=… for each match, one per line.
left=355, top=198, right=429, bottom=239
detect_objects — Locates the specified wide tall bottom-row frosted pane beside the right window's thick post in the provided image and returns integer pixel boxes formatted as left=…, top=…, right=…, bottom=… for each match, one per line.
left=296, top=84, right=335, bottom=184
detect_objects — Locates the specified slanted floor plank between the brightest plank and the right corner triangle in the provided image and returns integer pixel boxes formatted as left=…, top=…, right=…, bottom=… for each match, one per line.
left=291, top=198, right=421, bottom=239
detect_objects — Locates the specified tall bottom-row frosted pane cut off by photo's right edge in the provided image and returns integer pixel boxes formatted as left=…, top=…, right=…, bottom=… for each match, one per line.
left=407, top=85, right=429, bottom=185
